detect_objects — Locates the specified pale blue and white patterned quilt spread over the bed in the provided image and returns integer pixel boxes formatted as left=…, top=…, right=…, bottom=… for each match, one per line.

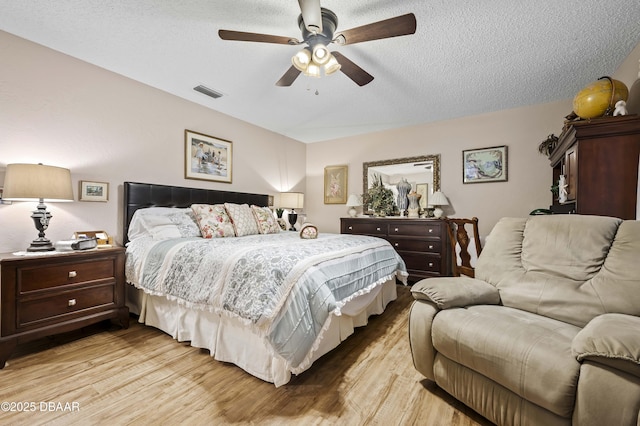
left=126, top=232, right=407, bottom=372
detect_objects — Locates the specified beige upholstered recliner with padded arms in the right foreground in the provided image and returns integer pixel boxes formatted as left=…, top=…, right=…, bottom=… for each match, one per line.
left=409, top=215, right=640, bottom=426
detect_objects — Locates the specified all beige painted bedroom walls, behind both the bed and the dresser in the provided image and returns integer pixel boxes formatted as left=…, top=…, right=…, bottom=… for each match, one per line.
left=0, top=31, right=640, bottom=252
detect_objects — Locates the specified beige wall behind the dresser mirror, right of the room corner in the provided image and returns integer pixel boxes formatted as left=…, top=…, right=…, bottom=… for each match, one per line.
left=305, top=44, right=640, bottom=236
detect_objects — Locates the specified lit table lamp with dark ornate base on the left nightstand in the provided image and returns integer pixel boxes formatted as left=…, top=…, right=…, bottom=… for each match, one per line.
left=4, top=163, right=73, bottom=252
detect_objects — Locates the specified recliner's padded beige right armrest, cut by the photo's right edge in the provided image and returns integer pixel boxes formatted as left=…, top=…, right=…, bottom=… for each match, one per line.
left=571, top=314, right=640, bottom=377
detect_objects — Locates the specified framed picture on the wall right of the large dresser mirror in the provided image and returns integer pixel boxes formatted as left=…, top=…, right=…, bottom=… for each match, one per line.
left=462, top=145, right=508, bottom=183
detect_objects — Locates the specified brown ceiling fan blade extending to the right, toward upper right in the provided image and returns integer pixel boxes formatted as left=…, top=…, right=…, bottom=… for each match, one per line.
left=335, top=13, right=416, bottom=45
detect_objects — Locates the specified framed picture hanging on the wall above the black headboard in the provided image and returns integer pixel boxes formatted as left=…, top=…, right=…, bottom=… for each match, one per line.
left=184, top=130, right=233, bottom=183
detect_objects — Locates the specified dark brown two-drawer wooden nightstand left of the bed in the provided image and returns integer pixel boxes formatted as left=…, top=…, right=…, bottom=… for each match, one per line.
left=0, top=247, right=129, bottom=368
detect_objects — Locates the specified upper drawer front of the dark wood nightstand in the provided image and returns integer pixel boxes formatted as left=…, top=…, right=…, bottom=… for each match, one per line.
left=17, top=259, right=115, bottom=294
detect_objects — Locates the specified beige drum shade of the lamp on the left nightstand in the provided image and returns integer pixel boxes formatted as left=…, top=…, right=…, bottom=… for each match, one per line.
left=3, top=164, right=73, bottom=201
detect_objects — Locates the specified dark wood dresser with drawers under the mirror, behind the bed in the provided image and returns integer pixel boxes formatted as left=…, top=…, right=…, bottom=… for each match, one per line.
left=340, top=217, right=451, bottom=282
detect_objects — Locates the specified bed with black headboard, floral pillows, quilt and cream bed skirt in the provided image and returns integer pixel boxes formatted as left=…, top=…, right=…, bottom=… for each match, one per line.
left=123, top=182, right=407, bottom=386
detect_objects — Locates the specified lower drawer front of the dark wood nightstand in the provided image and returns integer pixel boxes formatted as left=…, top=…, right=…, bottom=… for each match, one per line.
left=18, top=283, right=116, bottom=327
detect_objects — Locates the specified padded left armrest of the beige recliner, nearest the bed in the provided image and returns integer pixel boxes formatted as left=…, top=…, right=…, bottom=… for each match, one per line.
left=411, top=276, right=500, bottom=309
